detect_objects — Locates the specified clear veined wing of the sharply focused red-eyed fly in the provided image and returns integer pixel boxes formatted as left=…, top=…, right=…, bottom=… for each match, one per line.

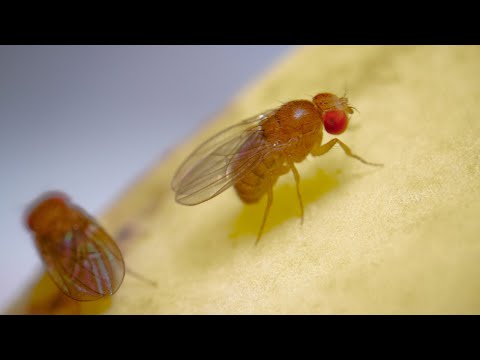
left=172, top=110, right=275, bottom=205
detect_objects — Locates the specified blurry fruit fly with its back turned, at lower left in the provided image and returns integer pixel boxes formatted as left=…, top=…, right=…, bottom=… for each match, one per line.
left=26, top=192, right=125, bottom=301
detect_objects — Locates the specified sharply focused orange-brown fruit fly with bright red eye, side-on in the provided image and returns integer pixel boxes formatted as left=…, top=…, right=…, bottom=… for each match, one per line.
left=171, top=93, right=381, bottom=242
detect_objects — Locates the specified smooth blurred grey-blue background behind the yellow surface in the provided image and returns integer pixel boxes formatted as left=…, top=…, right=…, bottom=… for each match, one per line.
left=0, top=46, right=291, bottom=312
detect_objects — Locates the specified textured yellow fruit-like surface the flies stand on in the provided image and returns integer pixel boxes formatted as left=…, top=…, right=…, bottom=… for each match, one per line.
left=10, top=46, right=480, bottom=314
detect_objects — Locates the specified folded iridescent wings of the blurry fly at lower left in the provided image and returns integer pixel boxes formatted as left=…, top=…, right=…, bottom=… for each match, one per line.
left=37, top=217, right=125, bottom=301
